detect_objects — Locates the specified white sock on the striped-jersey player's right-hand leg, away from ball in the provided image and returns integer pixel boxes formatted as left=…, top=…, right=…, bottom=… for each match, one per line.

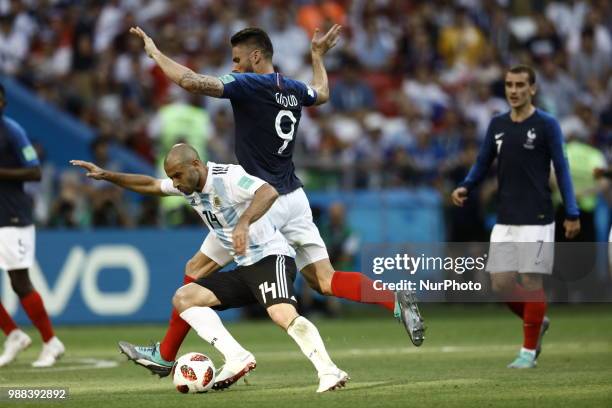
left=287, top=316, right=337, bottom=373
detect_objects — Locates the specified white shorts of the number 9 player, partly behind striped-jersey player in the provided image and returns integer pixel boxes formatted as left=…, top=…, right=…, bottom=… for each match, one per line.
left=200, top=188, right=329, bottom=270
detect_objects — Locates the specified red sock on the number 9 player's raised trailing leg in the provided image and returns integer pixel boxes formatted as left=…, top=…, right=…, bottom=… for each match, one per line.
left=331, top=271, right=395, bottom=311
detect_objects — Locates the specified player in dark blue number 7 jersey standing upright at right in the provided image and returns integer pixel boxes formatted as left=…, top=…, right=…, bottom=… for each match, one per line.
left=452, top=65, right=580, bottom=368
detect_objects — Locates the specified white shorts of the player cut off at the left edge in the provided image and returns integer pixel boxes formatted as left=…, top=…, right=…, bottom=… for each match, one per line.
left=0, top=225, right=36, bottom=271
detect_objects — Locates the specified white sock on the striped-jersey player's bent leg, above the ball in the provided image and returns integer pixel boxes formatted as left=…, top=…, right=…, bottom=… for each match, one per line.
left=180, top=306, right=249, bottom=361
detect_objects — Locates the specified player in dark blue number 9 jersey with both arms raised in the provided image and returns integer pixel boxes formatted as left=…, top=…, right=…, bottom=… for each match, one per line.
left=125, top=25, right=424, bottom=373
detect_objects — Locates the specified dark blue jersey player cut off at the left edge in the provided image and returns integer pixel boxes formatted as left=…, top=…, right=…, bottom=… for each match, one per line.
left=0, top=85, right=64, bottom=367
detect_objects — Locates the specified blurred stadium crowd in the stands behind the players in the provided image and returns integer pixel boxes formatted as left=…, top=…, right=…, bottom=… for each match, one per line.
left=0, top=0, right=612, bottom=233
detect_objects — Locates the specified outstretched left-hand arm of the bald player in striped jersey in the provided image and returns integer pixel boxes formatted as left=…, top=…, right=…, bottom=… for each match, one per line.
left=70, top=160, right=167, bottom=197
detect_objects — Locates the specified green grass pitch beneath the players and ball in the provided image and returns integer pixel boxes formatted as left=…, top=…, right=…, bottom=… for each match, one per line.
left=0, top=304, right=612, bottom=408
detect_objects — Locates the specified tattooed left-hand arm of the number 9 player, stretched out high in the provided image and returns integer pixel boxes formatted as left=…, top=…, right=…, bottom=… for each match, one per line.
left=130, top=27, right=223, bottom=98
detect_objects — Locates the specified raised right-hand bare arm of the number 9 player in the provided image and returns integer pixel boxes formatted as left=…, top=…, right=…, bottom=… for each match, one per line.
left=310, top=24, right=342, bottom=105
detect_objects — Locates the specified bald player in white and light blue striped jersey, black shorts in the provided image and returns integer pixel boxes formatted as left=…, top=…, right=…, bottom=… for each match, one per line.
left=72, top=144, right=349, bottom=392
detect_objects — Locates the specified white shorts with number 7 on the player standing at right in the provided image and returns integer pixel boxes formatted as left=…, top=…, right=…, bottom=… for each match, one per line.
left=486, top=223, right=555, bottom=274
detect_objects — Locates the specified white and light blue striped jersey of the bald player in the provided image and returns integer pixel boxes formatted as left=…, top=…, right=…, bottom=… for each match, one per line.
left=161, top=162, right=295, bottom=266
